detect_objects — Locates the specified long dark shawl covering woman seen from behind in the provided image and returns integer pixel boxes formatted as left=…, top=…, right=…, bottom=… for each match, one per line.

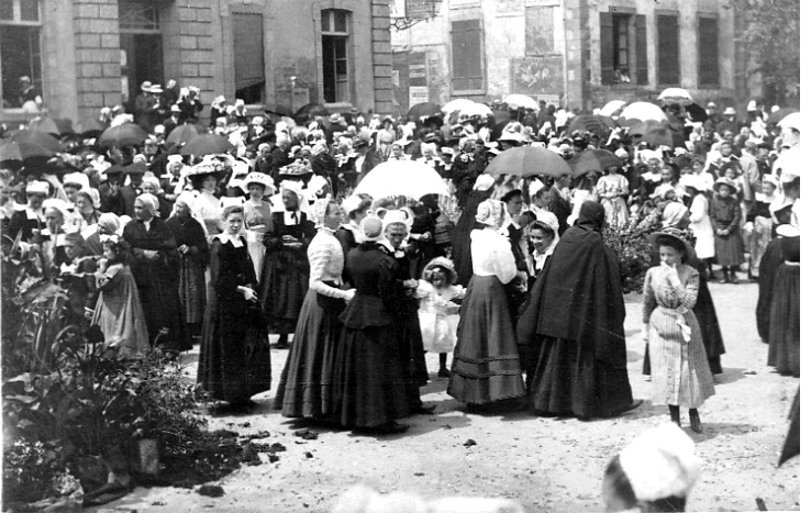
left=517, top=201, right=626, bottom=367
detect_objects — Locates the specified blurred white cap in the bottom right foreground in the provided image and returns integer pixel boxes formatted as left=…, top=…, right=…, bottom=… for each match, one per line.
left=620, top=423, right=701, bottom=501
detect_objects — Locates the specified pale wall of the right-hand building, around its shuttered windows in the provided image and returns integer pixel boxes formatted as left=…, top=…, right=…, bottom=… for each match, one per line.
left=392, top=0, right=735, bottom=110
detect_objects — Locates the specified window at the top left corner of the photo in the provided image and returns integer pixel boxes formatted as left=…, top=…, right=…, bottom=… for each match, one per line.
left=0, top=0, right=42, bottom=108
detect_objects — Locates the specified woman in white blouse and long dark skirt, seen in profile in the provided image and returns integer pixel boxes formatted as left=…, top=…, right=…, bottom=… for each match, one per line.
left=274, top=199, right=356, bottom=420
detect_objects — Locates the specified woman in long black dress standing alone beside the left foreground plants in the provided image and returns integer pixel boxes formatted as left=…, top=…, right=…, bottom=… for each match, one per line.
left=198, top=205, right=270, bottom=411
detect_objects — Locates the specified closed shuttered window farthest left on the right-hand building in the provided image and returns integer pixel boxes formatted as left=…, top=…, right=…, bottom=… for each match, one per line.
left=451, top=20, right=484, bottom=91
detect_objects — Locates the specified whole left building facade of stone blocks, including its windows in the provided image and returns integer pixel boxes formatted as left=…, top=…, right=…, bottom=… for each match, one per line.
left=0, top=0, right=392, bottom=120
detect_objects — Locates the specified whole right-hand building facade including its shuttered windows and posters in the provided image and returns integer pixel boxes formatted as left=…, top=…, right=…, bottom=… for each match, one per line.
left=392, top=0, right=738, bottom=112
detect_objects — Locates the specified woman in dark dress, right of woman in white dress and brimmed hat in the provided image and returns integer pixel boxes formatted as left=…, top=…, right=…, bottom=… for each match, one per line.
left=261, top=180, right=315, bottom=348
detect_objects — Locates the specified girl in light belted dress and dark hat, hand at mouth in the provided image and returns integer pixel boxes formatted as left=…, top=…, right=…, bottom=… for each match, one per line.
left=643, top=228, right=715, bottom=433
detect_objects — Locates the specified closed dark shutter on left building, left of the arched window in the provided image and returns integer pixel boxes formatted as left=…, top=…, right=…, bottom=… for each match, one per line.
left=231, top=12, right=265, bottom=90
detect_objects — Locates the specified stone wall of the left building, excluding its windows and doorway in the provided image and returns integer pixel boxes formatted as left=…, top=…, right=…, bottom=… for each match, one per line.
left=0, top=0, right=393, bottom=121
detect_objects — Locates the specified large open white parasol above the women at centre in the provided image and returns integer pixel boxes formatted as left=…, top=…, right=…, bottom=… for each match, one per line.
left=353, top=160, right=448, bottom=199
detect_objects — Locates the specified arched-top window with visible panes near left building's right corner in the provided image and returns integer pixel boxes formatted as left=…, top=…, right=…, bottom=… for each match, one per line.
left=321, top=9, right=351, bottom=103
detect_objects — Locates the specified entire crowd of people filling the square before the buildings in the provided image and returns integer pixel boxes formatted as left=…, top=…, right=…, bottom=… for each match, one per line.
left=0, top=82, right=801, bottom=433
